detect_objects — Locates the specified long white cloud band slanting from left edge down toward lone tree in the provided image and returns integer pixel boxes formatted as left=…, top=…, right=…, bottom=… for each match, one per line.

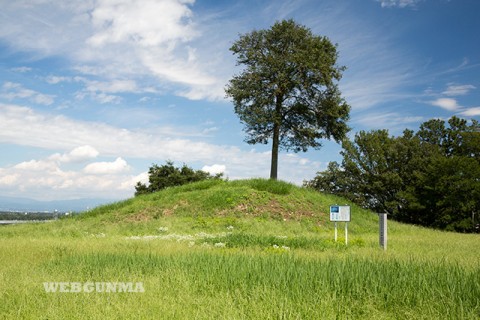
left=0, top=104, right=234, bottom=161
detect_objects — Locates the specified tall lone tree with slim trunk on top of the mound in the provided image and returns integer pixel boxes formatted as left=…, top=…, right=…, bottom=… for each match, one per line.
left=225, top=20, right=350, bottom=179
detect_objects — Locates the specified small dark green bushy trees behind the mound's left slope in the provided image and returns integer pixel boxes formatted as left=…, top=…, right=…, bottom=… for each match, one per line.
left=135, top=161, right=223, bottom=196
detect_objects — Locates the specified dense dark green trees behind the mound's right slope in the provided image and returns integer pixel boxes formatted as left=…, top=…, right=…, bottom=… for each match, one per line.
left=305, top=117, right=480, bottom=232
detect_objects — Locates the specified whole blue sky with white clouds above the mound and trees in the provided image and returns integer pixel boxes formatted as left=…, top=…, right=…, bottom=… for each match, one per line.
left=0, top=0, right=480, bottom=200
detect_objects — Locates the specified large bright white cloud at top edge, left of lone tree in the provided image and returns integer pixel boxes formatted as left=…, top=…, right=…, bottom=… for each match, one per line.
left=82, top=0, right=223, bottom=99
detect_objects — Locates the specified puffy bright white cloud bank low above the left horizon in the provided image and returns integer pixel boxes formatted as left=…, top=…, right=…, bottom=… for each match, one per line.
left=0, top=149, right=140, bottom=200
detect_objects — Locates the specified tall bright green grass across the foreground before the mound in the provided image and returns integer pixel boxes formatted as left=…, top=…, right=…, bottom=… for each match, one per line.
left=1, top=240, right=480, bottom=319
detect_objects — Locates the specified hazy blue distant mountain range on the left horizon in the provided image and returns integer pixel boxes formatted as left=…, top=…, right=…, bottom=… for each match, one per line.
left=0, top=196, right=119, bottom=212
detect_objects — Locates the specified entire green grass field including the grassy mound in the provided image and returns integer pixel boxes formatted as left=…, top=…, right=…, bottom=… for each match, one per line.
left=0, top=179, right=480, bottom=319
